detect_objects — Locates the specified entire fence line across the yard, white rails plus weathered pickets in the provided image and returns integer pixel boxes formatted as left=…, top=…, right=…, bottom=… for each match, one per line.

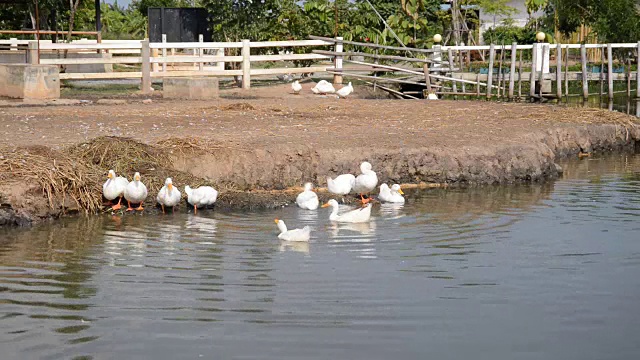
left=8, top=36, right=640, bottom=99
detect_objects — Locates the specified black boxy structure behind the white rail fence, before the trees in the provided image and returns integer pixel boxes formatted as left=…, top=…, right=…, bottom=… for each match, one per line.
left=147, top=7, right=211, bottom=42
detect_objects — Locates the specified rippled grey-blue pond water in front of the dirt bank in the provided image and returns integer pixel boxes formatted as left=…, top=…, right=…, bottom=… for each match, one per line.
left=0, top=154, right=640, bottom=360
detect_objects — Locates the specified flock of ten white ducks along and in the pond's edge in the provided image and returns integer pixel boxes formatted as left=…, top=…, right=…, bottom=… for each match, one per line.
left=102, top=161, right=404, bottom=245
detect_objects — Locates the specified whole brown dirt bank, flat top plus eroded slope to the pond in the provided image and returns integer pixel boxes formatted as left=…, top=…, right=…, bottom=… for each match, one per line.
left=0, top=83, right=640, bottom=225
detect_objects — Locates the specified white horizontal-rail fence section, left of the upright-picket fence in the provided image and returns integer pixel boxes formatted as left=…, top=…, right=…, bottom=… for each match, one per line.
left=16, top=39, right=335, bottom=92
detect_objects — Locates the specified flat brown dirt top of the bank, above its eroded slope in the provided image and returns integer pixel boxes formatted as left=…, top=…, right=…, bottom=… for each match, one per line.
left=0, top=84, right=634, bottom=150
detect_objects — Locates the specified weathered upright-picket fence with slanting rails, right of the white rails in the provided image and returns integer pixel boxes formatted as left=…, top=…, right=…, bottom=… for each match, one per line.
left=311, top=36, right=640, bottom=99
